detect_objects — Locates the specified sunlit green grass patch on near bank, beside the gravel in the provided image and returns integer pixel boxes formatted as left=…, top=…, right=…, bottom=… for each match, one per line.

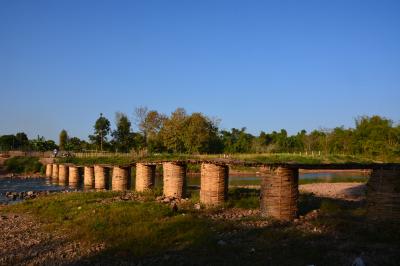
left=9, top=192, right=210, bottom=257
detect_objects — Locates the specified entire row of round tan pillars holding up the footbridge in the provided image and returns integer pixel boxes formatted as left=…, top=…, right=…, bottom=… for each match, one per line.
left=46, top=162, right=400, bottom=221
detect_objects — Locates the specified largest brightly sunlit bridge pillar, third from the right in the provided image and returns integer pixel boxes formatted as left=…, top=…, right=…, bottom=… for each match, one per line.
left=200, top=163, right=229, bottom=206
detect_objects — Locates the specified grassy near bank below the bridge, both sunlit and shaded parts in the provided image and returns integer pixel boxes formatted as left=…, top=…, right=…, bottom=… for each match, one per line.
left=1, top=189, right=400, bottom=265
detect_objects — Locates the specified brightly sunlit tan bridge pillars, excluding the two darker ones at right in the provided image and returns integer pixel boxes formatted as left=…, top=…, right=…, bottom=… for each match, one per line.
left=46, top=162, right=229, bottom=205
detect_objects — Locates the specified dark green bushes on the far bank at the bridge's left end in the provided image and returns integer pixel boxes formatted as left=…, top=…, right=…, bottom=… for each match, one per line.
left=4, top=156, right=43, bottom=174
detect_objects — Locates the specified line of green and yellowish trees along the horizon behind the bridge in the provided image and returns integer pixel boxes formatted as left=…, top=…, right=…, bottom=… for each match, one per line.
left=0, top=107, right=400, bottom=156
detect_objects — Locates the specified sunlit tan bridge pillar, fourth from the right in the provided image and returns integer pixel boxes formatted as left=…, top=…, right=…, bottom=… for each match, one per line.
left=163, top=162, right=186, bottom=199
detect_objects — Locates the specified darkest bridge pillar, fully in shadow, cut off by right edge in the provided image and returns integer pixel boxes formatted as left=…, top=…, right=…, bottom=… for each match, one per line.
left=366, top=167, right=400, bottom=223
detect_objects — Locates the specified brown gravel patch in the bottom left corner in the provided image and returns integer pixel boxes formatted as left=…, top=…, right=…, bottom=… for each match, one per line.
left=0, top=213, right=104, bottom=265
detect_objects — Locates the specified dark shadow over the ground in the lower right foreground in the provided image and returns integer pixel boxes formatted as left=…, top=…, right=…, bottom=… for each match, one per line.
left=74, top=189, right=400, bottom=265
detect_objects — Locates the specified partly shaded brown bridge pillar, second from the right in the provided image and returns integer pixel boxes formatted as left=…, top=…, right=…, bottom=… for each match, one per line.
left=260, top=167, right=299, bottom=221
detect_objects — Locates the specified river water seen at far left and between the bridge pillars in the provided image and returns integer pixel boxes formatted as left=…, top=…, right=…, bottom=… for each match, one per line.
left=0, top=171, right=367, bottom=203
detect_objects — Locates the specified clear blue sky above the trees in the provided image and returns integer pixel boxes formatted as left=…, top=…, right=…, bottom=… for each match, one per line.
left=0, top=0, right=400, bottom=139
